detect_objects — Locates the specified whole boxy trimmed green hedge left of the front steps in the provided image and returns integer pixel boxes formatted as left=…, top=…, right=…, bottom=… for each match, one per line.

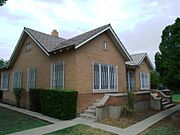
left=30, top=89, right=78, bottom=120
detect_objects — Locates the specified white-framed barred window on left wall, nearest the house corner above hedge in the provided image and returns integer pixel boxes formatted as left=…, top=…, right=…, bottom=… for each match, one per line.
left=50, top=60, right=65, bottom=89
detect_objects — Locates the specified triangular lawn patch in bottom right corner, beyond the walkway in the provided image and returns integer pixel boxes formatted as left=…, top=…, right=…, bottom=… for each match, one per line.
left=138, top=111, right=180, bottom=135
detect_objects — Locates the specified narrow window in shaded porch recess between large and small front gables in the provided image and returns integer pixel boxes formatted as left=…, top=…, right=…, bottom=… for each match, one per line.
left=126, top=71, right=135, bottom=90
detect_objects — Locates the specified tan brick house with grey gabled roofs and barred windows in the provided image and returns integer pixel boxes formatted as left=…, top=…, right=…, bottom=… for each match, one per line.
left=0, top=24, right=152, bottom=113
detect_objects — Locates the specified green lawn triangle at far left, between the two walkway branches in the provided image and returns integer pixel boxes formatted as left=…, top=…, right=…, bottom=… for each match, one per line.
left=0, top=107, right=49, bottom=135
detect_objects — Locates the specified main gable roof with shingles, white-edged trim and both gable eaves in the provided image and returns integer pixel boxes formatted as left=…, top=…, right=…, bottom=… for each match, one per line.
left=8, top=24, right=132, bottom=67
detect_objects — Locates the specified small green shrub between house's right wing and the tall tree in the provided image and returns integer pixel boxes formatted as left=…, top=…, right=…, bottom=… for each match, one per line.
left=151, top=70, right=160, bottom=89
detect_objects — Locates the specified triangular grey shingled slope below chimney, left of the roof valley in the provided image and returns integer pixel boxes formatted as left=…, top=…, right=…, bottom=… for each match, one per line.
left=24, top=27, right=65, bottom=52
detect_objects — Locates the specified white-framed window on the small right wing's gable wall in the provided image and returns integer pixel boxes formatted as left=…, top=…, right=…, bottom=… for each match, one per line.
left=140, top=72, right=150, bottom=90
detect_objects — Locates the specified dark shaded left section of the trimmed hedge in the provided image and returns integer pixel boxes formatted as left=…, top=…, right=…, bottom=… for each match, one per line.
left=29, top=89, right=41, bottom=112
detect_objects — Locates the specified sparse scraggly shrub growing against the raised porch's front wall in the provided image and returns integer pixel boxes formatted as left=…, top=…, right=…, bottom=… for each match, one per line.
left=121, top=91, right=135, bottom=116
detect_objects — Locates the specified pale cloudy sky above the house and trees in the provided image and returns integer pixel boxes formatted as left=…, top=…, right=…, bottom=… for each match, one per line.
left=0, top=0, right=180, bottom=63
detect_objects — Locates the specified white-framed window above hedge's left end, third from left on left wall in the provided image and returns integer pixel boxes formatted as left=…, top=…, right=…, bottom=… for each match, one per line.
left=27, top=68, right=36, bottom=91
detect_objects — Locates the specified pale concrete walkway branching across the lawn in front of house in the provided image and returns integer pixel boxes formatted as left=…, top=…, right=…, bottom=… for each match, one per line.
left=0, top=103, right=180, bottom=135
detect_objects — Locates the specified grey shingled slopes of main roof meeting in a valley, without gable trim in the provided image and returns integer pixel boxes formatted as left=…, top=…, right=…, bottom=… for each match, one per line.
left=24, top=24, right=110, bottom=52
